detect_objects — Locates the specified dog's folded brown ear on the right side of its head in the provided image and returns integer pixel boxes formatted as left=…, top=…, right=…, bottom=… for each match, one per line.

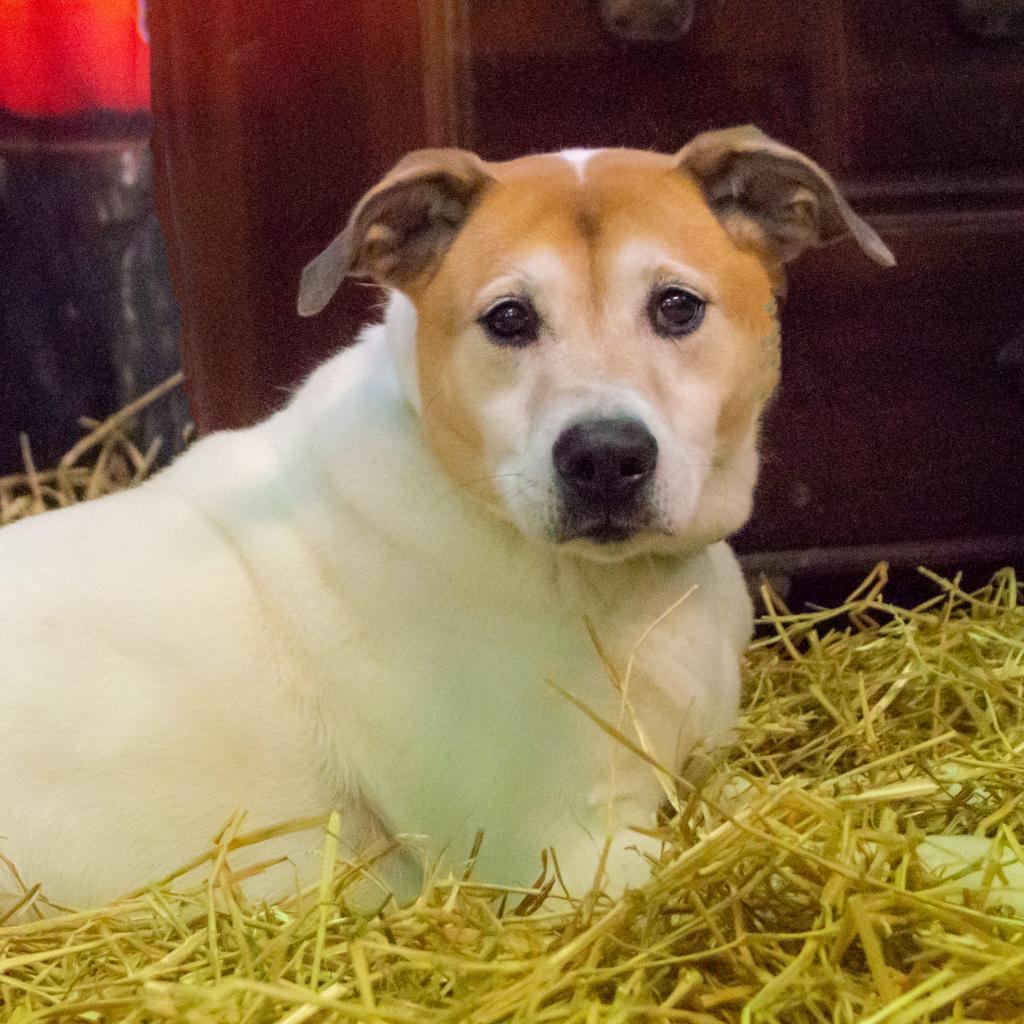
left=677, top=125, right=896, bottom=266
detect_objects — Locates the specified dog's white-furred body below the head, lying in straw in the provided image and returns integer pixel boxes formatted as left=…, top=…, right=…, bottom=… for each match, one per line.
left=0, top=300, right=751, bottom=905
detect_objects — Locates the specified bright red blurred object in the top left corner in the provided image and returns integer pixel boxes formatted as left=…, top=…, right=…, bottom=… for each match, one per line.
left=0, top=0, right=150, bottom=117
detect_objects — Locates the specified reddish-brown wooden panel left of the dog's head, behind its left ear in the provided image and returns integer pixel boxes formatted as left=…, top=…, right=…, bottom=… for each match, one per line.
left=151, top=0, right=429, bottom=430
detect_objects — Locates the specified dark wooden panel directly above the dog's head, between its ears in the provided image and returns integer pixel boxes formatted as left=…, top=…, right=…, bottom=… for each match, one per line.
left=464, top=0, right=845, bottom=163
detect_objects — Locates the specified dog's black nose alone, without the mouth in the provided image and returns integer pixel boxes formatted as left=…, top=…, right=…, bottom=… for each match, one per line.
left=552, top=419, right=657, bottom=509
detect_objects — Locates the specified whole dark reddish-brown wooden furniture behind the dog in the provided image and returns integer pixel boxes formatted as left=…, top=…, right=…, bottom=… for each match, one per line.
left=151, top=0, right=1024, bottom=570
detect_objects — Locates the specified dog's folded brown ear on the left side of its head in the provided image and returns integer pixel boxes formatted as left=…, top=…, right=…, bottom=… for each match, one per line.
left=298, top=150, right=494, bottom=316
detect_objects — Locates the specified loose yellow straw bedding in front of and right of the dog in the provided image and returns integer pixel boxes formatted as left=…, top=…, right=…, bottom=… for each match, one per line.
left=0, top=385, right=1024, bottom=1024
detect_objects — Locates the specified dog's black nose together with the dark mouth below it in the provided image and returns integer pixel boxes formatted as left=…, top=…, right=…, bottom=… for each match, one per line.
left=552, top=418, right=657, bottom=544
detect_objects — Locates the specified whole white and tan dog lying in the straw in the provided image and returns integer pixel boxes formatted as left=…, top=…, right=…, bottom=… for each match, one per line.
left=0, top=129, right=892, bottom=905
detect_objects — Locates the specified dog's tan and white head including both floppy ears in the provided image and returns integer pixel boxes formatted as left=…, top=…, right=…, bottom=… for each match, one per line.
left=299, top=128, right=893, bottom=560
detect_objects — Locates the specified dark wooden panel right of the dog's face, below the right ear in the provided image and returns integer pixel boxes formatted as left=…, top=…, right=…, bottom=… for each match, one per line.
left=740, top=212, right=1024, bottom=550
